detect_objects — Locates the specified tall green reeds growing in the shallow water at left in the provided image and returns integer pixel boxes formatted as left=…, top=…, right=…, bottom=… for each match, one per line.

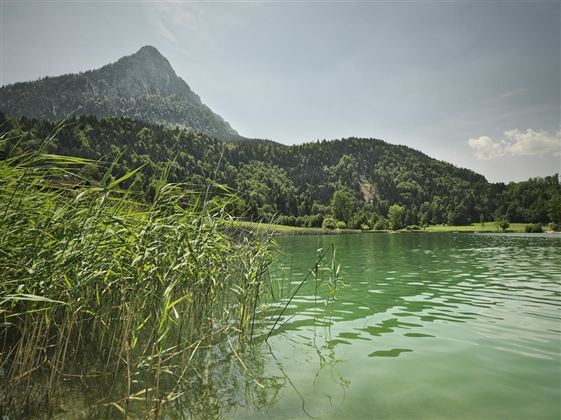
left=0, top=139, right=272, bottom=418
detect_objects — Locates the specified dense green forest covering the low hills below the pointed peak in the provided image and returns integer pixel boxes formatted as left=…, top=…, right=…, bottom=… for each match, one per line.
left=0, top=114, right=561, bottom=229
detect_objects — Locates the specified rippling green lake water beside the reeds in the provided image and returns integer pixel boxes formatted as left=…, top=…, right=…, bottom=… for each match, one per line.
left=235, top=233, right=561, bottom=419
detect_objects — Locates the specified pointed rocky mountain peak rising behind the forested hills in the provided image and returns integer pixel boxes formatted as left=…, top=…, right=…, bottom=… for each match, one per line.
left=0, top=46, right=238, bottom=140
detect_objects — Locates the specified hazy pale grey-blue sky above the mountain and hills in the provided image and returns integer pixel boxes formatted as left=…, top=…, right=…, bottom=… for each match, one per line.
left=0, top=0, right=561, bottom=181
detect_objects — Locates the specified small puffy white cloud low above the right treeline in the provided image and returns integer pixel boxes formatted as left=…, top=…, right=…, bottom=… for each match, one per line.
left=468, top=128, right=561, bottom=160
